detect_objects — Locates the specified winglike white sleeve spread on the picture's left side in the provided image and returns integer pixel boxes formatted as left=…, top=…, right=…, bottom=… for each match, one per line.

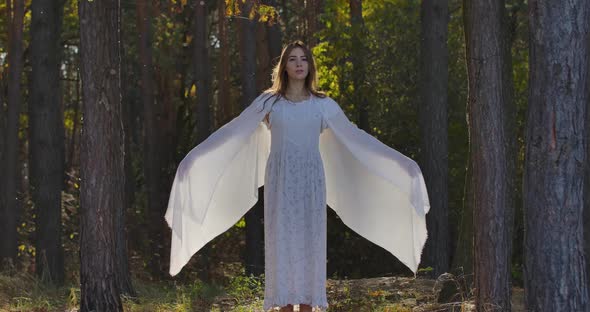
left=165, top=92, right=270, bottom=275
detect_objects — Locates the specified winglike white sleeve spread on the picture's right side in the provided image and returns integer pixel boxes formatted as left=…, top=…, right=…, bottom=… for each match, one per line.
left=320, top=98, right=430, bottom=273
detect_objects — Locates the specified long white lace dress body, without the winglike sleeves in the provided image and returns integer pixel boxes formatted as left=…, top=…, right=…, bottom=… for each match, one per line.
left=264, top=99, right=328, bottom=311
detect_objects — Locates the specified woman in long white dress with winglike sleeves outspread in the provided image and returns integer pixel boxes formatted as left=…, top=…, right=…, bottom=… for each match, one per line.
left=166, top=41, right=429, bottom=311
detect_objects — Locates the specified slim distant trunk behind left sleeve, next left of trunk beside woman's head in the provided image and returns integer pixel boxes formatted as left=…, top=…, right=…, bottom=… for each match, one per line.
left=217, top=0, right=233, bottom=125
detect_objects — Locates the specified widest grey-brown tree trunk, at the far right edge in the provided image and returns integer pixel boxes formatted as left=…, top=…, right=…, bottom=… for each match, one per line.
left=524, top=0, right=590, bottom=311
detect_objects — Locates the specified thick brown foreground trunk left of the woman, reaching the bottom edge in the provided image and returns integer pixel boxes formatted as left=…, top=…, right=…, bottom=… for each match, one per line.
left=79, top=0, right=125, bottom=312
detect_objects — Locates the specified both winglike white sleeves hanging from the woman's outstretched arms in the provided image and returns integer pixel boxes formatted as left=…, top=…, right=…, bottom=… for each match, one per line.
left=165, top=94, right=430, bottom=275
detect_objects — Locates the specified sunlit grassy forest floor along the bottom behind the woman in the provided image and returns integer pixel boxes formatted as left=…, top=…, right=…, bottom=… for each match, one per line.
left=0, top=266, right=525, bottom=312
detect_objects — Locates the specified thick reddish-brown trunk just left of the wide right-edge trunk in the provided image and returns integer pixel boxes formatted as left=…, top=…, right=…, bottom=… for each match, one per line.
left=464, top=0, right=515, bottom=311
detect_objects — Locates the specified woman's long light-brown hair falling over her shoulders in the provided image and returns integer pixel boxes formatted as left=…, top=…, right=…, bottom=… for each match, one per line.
left=263, top=40, right=326, bottom=109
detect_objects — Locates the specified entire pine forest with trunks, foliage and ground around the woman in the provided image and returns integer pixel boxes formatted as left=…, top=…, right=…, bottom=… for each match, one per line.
left=0, top=0, right=590, bottom=312
